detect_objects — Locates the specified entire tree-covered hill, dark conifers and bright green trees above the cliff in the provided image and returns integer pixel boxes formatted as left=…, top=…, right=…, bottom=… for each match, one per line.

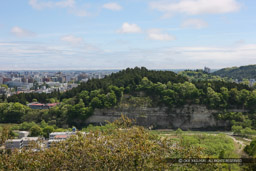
left=0, top=67, right=256, bottom=128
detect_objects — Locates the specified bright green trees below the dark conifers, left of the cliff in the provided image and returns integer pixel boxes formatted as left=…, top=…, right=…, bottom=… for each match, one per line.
left=0, top=86, right=123, bottom=128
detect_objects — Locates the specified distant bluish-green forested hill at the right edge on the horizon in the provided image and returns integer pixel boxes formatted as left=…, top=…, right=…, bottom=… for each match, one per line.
left=213, top=65, right=256, bottom=80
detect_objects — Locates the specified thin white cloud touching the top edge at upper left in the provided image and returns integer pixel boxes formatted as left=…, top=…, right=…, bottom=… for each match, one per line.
left=29, top=0, right=75, bottom=9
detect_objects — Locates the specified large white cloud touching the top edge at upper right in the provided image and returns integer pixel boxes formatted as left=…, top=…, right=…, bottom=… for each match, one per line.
left=149, top=0, right=240, bottom=16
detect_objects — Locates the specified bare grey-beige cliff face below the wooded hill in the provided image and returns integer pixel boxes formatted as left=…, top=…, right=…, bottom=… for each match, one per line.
left=86, top=105, right=244, bottom=130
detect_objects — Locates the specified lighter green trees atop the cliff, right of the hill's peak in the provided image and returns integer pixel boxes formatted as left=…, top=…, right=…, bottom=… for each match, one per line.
left=137, top=77, right=256, bottom=110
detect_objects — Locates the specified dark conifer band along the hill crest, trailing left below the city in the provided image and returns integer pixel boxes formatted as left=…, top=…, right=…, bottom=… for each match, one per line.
left=8, top=67, right=187, bottom=104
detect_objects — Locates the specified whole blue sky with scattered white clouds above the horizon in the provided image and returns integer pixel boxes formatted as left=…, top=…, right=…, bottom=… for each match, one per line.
left=0, top=0, right=256, bottom=70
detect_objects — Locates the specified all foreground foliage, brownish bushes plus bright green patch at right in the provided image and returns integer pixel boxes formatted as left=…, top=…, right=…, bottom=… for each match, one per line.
left=0, top=116, right=254, bottom=170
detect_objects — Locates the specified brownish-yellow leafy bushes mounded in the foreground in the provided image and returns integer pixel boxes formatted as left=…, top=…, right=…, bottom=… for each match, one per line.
left=0, top=118, right=206, bottom=170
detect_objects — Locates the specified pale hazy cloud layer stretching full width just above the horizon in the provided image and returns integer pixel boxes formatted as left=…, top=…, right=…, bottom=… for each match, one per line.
left=0, top=42, right=256, bottom=70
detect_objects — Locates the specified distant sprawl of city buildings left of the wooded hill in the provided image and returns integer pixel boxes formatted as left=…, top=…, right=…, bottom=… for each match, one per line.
left=0, top=71, right=114, bottom=97
